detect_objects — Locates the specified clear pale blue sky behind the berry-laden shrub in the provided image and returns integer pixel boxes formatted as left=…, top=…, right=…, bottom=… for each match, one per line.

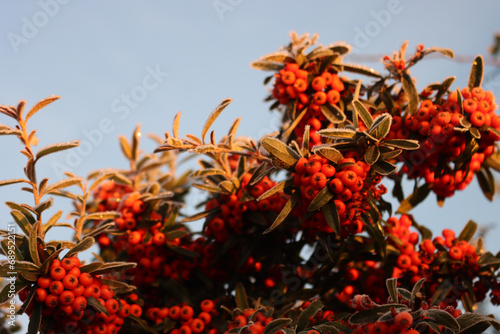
left=0, top=0, right=500, bottom=328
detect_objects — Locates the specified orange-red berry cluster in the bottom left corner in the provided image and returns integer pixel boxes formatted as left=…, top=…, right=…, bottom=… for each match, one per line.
left=27, top=257, right=142, bottom=334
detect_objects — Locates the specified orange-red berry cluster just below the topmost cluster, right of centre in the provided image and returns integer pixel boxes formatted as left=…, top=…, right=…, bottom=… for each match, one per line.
left=293, top=154, right=386, bottom=238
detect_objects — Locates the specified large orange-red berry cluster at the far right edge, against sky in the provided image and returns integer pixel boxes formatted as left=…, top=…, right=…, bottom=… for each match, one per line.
left=386, top=87, right=500, bottom=197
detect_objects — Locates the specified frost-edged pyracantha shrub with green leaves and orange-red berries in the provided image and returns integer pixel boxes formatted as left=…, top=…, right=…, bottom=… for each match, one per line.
left=0, top=33, right=500, bottom=334
